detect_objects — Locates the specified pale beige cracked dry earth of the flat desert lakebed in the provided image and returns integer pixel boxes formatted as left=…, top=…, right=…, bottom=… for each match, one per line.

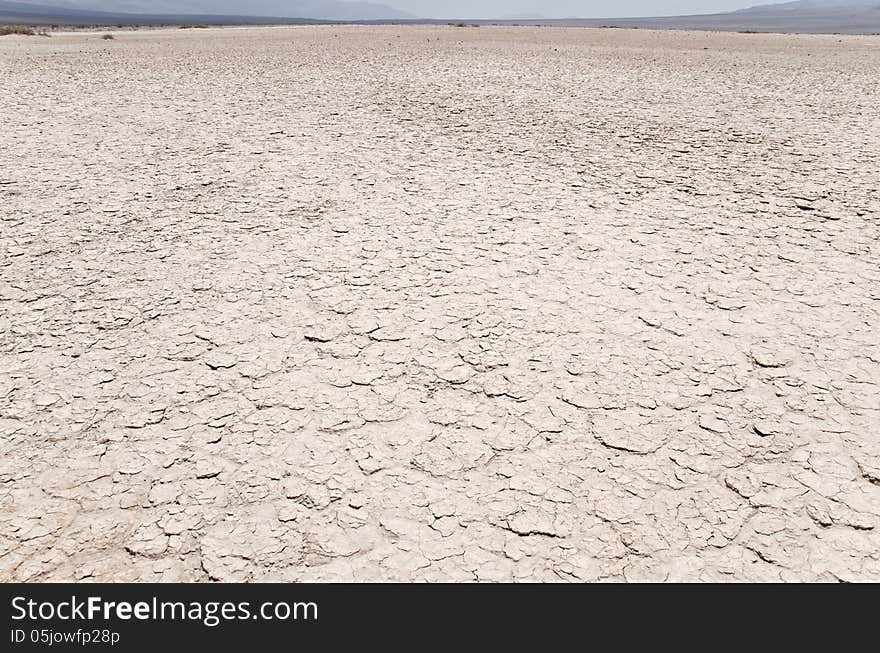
left=0, top=26, right=880, bottom=581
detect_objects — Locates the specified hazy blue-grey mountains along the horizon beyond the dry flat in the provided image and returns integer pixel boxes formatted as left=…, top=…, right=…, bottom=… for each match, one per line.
left=0, top=0, right=880, bottom=34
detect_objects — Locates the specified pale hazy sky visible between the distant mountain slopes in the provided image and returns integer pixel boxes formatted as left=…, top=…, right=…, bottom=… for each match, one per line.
left=384, top=0, right=764, bottom=18
